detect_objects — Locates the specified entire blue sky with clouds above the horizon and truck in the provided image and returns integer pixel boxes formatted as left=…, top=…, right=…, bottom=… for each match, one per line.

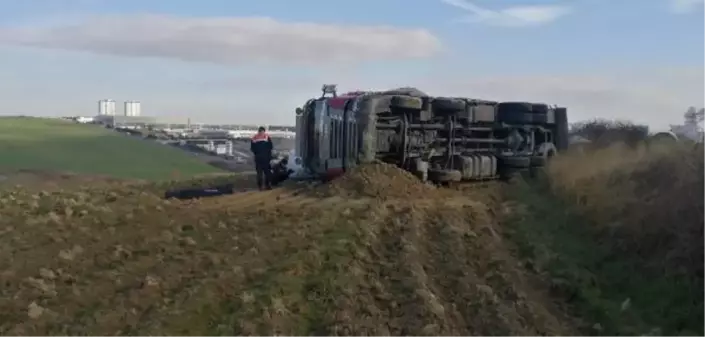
left=0, top=0, right=705, bottom=128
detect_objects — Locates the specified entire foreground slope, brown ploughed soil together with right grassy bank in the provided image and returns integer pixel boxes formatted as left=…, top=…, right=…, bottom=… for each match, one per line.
left=0, top=132, right=705, bottom=337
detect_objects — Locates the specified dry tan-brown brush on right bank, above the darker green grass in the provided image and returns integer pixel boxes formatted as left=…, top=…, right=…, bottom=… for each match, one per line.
left=549, top=145, right=705, bottom=276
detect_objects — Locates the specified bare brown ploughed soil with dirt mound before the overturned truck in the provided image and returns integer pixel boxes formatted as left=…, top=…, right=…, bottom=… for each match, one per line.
left=0, top=162, right=579, bottom=336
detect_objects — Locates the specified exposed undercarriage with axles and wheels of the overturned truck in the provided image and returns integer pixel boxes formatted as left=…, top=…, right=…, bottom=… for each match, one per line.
left=376, top=98, right=558, bottom=182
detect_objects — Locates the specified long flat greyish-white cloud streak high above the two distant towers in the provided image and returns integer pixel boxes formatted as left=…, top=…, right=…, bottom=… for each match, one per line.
left=0, top=15, right=441, bottom=64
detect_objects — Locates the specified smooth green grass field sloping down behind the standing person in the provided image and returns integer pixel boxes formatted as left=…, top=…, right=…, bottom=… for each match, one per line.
left=0, top=117, right=223, bottom=180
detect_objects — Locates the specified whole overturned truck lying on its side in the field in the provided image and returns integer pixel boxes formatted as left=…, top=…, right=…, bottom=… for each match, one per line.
left=295, top=85, right=568, bottom=183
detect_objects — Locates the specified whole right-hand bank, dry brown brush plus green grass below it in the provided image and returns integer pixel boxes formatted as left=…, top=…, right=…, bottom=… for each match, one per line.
left=503, top=143, right=705, bottom=336
